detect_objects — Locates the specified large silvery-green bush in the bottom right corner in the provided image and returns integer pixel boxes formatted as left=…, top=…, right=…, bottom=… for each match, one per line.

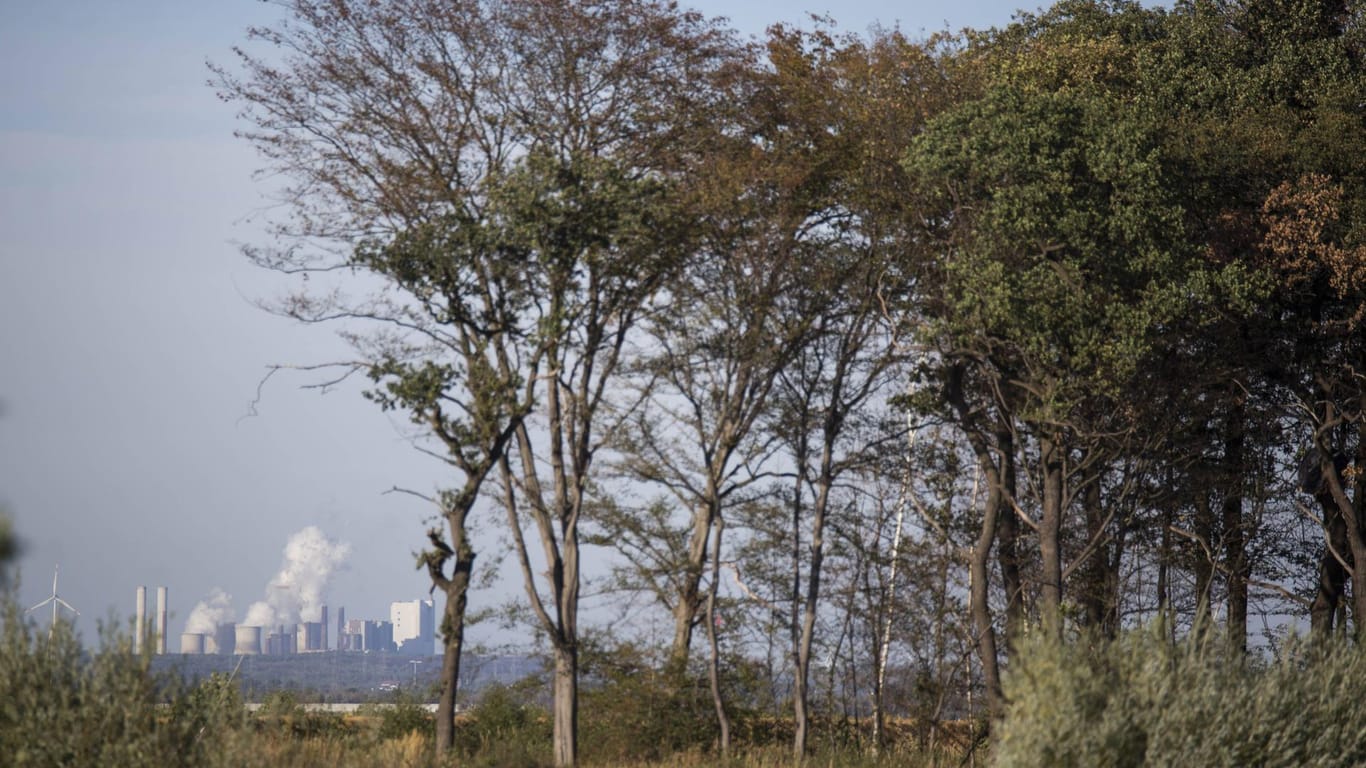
left=994, top=630, right=1366, bottom=768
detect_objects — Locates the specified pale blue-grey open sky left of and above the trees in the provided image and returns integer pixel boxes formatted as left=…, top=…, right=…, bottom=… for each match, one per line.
left=0, top=0, right=1034, bottom=650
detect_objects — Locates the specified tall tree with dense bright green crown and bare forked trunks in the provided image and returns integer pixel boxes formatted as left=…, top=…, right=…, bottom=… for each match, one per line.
left=906, top=3, right=1195, bottom=712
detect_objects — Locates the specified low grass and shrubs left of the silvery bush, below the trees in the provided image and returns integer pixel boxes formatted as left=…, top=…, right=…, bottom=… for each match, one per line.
left=0, top=599, right=971, bottom=768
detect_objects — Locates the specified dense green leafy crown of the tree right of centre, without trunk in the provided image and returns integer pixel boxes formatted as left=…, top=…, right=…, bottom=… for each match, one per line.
left=907, top=76, right=1190, bottom=413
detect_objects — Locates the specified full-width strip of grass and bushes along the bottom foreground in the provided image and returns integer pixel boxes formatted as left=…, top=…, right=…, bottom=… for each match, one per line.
left=8, top=600, right=1366, bottom=768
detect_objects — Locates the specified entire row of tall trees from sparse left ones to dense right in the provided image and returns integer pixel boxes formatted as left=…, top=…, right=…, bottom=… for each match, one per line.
left=214, top=0, right=1366, bottom=765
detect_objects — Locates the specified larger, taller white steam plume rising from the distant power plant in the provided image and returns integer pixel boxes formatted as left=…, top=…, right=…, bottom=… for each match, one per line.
left=242, top=525, right=351, bottom=627
